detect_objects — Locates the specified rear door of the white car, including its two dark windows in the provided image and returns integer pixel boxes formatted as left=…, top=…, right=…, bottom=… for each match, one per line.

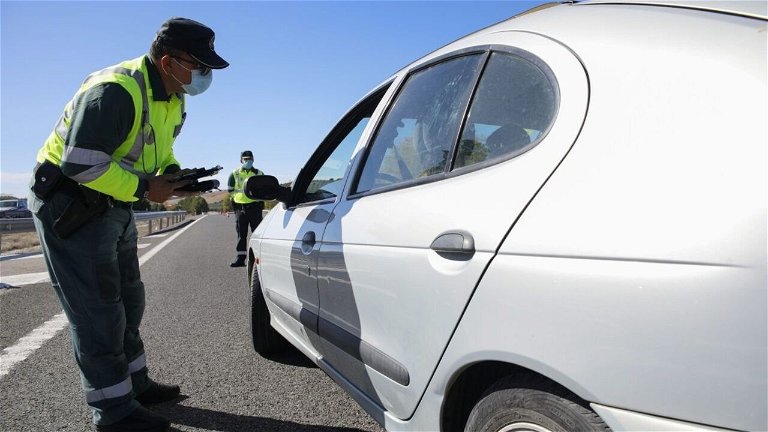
left=318, top=32, right=588, bottom=419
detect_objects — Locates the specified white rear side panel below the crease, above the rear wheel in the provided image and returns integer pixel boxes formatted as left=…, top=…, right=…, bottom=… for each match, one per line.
left=444, top=254, right=766, bottom=430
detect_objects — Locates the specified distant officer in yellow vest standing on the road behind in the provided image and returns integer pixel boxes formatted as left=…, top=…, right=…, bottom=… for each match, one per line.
left=228, top=150, right=264, bottom=267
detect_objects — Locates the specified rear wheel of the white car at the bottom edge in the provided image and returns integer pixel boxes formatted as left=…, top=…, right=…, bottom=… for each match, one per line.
left=464, top=377, right=610, bottom=432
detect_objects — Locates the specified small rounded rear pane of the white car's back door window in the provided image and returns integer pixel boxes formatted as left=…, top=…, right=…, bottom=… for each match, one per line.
left=454, top=52, right=557, bottom=168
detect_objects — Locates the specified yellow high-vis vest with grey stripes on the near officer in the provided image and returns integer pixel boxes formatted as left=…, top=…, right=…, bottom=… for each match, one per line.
left=37, top=56, right=184, bottom=201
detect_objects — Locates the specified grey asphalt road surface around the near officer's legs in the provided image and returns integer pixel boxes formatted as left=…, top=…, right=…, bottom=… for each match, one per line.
left=0, top=215, right=382, bottom=432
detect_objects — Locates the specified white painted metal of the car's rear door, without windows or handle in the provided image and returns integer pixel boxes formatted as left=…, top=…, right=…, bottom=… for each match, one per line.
left=318, top=32, right=589, bottom=418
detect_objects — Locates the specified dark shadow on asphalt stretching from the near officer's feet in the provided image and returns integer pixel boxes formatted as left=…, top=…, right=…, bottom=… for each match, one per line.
left=160, top=404, right=372, bottom=432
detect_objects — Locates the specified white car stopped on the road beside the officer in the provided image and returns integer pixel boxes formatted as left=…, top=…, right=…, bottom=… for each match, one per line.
left=247, top=1, right=768, bottom=432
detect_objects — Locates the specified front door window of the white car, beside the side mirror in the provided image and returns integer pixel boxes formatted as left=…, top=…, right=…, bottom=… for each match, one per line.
left=294, top=84, right=389, bottom=204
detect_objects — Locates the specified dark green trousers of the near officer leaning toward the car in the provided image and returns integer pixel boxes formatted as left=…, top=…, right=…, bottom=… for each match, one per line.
left=30, top=193, right=149, bottom=424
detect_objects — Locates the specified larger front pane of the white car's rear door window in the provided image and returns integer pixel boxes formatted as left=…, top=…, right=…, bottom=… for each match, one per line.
left=355, top=55, right=483, bottom=193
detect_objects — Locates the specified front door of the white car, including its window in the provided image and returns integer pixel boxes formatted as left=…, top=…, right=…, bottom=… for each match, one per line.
left=258, top=86, right=387, bottom=355
